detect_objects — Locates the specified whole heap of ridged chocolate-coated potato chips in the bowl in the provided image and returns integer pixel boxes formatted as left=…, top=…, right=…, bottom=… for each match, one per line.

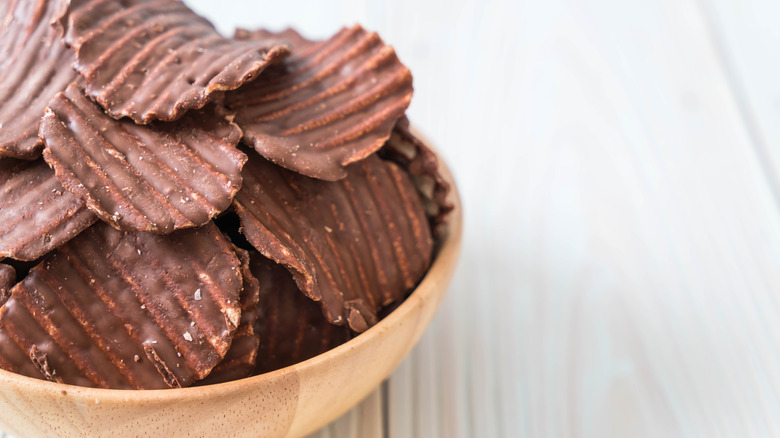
left=0, top=0, right=452, bottom=389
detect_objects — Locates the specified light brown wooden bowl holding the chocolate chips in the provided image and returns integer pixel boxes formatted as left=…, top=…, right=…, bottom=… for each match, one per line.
left=0, top=145, right=462, bottom=438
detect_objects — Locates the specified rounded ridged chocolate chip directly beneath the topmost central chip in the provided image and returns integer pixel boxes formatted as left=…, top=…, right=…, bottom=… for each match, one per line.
left=41, top=84, right=246, bottom=234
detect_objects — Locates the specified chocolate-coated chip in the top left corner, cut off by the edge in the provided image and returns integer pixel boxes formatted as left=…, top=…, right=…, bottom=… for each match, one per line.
left=0, top=0, right=77, bottom=160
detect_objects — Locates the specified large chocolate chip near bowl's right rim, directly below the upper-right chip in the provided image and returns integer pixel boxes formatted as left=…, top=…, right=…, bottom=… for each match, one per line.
left=234, top=154, right=433, bottom=332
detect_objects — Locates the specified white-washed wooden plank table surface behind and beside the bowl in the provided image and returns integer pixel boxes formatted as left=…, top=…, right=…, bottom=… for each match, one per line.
left=9, top=0, right=780, bottom=438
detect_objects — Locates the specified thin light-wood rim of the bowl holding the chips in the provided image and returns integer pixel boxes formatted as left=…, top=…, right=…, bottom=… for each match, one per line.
left=0, top=138, right=463, bottom=403
